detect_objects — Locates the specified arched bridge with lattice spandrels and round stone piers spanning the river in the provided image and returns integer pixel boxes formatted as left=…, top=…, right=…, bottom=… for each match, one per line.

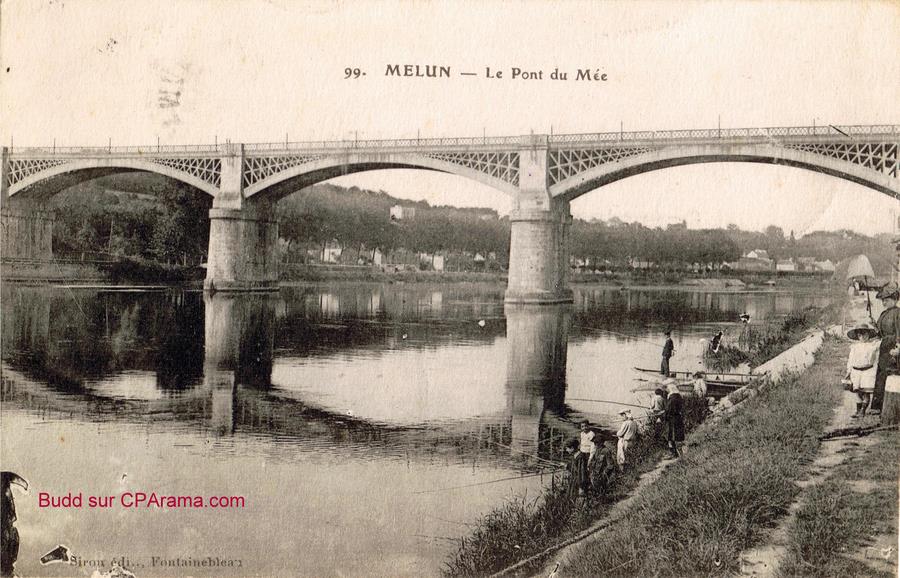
left=0, top=125, right=900, bottom=303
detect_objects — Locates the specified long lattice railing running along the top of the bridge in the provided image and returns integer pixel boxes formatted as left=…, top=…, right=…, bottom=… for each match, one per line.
left=9, top=124, right=900, bottom=156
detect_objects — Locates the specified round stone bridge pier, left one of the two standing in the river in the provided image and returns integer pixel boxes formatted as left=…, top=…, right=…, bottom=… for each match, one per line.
left=204, top=145, right=278, bottom=292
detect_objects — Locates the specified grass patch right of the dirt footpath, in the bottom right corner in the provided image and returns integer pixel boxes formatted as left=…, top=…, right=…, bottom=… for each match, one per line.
left=779, top=431, right=900, bottom=577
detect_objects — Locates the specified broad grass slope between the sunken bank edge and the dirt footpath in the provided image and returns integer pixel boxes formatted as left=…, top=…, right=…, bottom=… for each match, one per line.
left=566, top=340, right=846, bottom=576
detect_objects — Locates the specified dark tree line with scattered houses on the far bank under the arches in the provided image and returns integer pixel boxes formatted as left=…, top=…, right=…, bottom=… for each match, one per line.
left=53, top=173, right=894, bottom=268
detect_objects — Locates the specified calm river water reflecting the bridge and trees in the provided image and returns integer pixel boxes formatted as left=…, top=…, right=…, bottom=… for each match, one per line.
left=0, top=283, right=827, bottom=577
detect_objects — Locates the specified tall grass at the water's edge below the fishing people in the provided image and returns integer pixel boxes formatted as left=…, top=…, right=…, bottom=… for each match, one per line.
left=444, top=396, right=706, bottom=576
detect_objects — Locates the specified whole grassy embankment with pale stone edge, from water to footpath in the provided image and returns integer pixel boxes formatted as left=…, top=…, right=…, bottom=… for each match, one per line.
left=447, top=308, right=846, bottom=576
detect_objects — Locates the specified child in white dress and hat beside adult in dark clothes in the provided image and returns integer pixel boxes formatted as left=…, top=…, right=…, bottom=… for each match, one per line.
left=844, top=283, right=900, bottom=418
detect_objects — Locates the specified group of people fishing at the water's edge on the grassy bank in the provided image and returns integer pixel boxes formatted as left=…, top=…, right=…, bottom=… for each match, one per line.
left=566, top=378, right=684, bottom=495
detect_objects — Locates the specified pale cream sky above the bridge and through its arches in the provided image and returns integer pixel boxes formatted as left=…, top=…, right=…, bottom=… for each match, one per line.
left=0, top=0, right=900, bottom=235
